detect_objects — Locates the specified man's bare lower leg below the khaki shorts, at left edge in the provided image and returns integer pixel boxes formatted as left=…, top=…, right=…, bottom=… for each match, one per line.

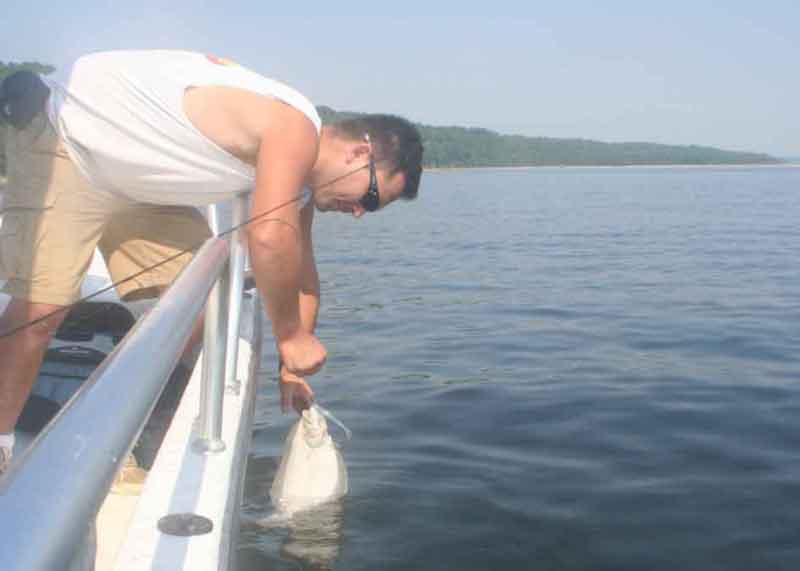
left=0, top=299, right=66, bottom=433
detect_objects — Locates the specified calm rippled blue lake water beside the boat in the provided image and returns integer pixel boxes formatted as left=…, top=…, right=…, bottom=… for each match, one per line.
left=239, top=168, right=800, bottom=571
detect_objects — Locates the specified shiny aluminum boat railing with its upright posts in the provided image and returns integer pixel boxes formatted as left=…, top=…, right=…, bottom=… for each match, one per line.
left=0, top=196, right=252, bottom=571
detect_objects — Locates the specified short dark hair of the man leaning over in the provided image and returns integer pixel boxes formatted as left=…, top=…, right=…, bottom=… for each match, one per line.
left=331, top=114, right=423, bottom=200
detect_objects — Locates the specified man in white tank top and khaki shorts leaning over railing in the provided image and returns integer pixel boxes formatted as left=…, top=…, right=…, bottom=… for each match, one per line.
left=0, top=51, right=422, bottom=471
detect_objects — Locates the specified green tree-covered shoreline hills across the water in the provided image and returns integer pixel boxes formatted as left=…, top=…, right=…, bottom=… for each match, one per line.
left=0, top=61, right=784, bottom=175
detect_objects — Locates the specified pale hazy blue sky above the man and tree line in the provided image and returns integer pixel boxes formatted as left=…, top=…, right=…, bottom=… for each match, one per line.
left=0, top=0, right=800, bottom=157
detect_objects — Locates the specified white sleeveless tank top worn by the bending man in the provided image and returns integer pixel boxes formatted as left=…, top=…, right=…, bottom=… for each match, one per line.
left=44, top=50, right=321, bottom=206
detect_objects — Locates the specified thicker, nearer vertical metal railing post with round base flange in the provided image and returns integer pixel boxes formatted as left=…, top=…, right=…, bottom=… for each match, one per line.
left=192, top=205, right=230, bottom=454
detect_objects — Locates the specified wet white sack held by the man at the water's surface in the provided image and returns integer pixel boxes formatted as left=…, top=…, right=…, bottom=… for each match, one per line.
left=270, top=405, right=347, bottom=513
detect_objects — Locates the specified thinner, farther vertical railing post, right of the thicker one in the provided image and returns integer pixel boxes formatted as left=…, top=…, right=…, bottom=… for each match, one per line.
left=225, top=194, right=249, bottom=394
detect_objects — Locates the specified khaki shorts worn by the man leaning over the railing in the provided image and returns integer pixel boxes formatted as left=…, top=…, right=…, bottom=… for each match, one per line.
left=0, top=114, right=210, bottom=306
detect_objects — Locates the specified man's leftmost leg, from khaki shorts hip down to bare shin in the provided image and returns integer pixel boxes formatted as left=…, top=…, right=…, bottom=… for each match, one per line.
left=0, top=110, right=112, bottom=442
